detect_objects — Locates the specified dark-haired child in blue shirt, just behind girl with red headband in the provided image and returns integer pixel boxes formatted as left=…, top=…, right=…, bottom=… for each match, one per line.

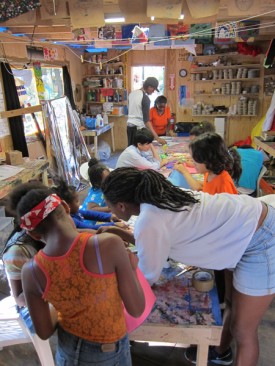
left=52, top=181, right=121, bottom=230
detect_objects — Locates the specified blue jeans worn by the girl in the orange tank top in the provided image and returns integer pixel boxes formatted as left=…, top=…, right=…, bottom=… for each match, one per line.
left=55, top=326, right=132, bottom=366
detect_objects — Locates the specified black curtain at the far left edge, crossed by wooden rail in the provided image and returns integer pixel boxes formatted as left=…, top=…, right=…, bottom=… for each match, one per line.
left=1, top=62, right=29, bottom=156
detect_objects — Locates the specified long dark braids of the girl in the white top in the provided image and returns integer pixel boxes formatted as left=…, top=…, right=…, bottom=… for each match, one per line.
left=101, top=168, right=199, bottom=212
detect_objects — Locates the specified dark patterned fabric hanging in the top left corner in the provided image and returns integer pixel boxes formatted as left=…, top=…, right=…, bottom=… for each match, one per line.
left=0, top=0, right=40, bottom=22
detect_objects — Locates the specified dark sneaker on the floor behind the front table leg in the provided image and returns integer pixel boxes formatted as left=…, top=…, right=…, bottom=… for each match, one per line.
left=184, top=346, right=233, bottom=365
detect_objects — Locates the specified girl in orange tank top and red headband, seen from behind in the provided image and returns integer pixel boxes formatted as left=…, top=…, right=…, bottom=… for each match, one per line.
left=17, top=189, right=145, bottom=366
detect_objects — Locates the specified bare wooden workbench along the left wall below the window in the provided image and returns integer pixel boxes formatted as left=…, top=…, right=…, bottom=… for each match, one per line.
left=0, top=158, right=49, bottom=199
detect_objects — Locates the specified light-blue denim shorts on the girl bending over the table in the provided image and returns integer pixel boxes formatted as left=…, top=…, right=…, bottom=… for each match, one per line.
left=233, top=206, right=275, bottom=296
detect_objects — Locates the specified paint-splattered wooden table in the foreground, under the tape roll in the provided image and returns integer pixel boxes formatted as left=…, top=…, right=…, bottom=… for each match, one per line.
left=129, top=266, right=222, bottom=366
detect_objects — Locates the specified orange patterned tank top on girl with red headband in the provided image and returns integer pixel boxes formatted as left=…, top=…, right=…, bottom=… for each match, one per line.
left=35, top=233, right=126, bottom=343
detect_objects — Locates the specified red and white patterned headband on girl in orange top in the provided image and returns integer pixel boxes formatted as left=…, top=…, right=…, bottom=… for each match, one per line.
left=20, top=193, right=62, bottom=231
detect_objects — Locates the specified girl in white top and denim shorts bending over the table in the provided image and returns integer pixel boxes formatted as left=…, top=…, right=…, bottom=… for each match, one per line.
left=102, top=168, right=275, bottom=366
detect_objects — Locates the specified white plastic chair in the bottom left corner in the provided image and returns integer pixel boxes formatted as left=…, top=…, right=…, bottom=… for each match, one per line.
left=0, top=296, right=55, bottom=366
